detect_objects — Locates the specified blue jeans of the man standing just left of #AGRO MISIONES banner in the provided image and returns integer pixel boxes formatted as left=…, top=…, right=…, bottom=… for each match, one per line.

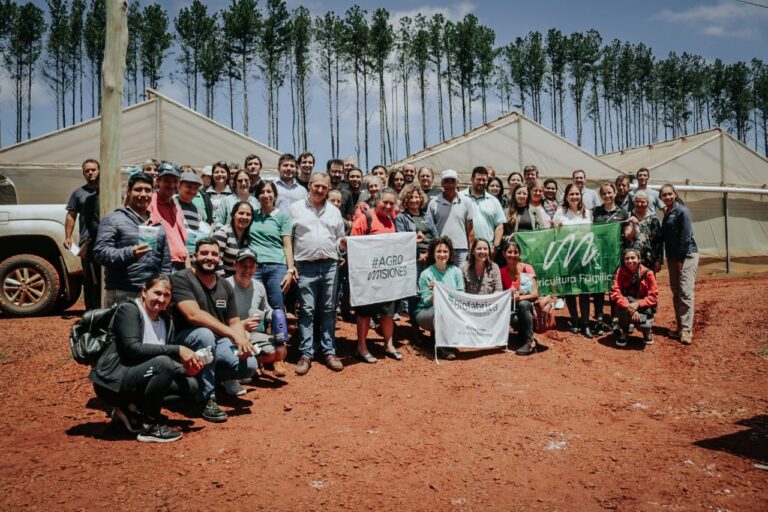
left=296, top=259, right=338, bottom=359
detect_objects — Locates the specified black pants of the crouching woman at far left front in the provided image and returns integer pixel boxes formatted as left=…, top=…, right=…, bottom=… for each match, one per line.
left=120, top=356, right=196, bottom=418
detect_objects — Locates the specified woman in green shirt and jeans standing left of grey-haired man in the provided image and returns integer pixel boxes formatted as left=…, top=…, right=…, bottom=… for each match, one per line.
left=248, top=180, right=298, bottom=310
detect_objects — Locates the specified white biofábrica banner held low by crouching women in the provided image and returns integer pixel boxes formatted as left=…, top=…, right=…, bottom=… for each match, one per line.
left=433, top=282, right=512, bottom=348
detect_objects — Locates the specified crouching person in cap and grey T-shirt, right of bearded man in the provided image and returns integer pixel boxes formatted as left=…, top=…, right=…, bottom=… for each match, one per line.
left=226, top=247, right=288, bottom=377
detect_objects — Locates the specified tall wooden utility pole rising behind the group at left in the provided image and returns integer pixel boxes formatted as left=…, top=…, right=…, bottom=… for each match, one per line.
left=99, top=0, right=128, bottom=304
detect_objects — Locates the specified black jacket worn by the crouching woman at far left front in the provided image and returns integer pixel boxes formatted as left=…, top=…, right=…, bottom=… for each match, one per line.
left=88, top=300, right=179, bottom=393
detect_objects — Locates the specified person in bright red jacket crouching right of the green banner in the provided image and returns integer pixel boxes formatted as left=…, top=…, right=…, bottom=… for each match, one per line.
left=610, top=247, right=658, bottom=347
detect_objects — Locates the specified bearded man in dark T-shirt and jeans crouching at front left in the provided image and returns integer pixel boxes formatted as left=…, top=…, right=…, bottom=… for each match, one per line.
left=171, top=238, right=258, bottom=423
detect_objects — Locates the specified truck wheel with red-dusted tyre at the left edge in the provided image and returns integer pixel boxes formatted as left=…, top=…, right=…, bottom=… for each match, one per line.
left=0, top=254, right=60, bottom=316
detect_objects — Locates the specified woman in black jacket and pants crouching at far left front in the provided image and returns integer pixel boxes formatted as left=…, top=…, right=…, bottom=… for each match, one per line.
left=89, top=274, right=203, bottom=443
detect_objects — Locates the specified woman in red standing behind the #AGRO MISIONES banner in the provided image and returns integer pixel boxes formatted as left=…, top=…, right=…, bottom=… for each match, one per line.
left=350, top=188, right=403, bottom=364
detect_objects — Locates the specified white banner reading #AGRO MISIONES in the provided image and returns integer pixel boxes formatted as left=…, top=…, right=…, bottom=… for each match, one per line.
left=347, top=233, right=417, bottom=306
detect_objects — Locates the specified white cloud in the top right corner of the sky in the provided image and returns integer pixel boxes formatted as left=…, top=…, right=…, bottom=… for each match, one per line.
left=656, top=1, right=768, bottom=40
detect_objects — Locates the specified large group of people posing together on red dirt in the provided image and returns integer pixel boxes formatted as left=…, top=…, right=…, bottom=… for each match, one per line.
left=65, top=153, right=698, bottom=442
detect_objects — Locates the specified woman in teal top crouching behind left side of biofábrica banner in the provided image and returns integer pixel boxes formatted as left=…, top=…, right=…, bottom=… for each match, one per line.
left=414, top=236, right=464, bottom=359
